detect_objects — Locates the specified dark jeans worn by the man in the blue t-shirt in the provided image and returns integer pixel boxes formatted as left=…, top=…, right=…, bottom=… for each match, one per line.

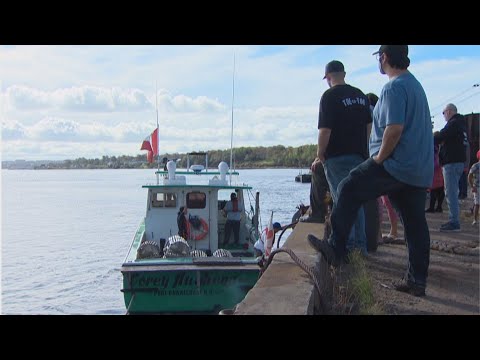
left=331, top=158, right=430, bottom=287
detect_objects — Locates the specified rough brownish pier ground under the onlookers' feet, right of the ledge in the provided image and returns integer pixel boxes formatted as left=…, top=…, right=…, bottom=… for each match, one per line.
left=367, top=198, right=480, bottom=315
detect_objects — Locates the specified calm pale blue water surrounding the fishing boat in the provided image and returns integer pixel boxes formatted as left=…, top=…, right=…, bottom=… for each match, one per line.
left=1, top=169, right=310, bottom=314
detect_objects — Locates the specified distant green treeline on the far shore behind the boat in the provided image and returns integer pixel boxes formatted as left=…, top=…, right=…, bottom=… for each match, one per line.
left=35, top=145, right=317, bottom=169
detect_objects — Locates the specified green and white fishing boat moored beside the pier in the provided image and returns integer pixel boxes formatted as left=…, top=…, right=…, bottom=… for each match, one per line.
left=121, top=152, right=260, bottom=314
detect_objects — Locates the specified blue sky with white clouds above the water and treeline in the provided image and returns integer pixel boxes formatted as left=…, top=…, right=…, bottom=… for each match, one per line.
left=0, top=45, right=480, bottom=160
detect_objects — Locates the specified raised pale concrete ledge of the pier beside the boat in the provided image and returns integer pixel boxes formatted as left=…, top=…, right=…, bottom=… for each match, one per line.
left=235, top=223, right=331, bottom=315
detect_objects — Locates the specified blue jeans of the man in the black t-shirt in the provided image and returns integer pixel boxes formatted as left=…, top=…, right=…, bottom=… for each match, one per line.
left=324, top=154, right=368, bottom=255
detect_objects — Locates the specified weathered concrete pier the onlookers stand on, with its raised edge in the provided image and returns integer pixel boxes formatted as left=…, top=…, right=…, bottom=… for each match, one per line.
left=234, top=201, right=480, bottom=315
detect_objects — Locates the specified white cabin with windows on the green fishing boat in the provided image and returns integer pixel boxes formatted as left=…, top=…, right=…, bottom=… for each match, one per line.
left=133, top=155, right=257, bottom=257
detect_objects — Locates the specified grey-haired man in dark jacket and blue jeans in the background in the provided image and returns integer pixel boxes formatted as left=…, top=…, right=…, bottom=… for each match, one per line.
left=434, top=104, right=467, bottom=232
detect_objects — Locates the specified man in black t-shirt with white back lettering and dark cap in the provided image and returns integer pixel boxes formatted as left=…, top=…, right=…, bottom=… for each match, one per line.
left=312, top=60, right=372, bottom=255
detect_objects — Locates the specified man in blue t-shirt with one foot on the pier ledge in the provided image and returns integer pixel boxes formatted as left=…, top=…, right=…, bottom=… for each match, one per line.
left=308, top=45, right=433, bottom=296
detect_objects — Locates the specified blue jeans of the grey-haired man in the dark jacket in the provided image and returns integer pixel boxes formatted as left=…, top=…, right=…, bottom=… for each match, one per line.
left=442, top=162, right=463, bottom=226
